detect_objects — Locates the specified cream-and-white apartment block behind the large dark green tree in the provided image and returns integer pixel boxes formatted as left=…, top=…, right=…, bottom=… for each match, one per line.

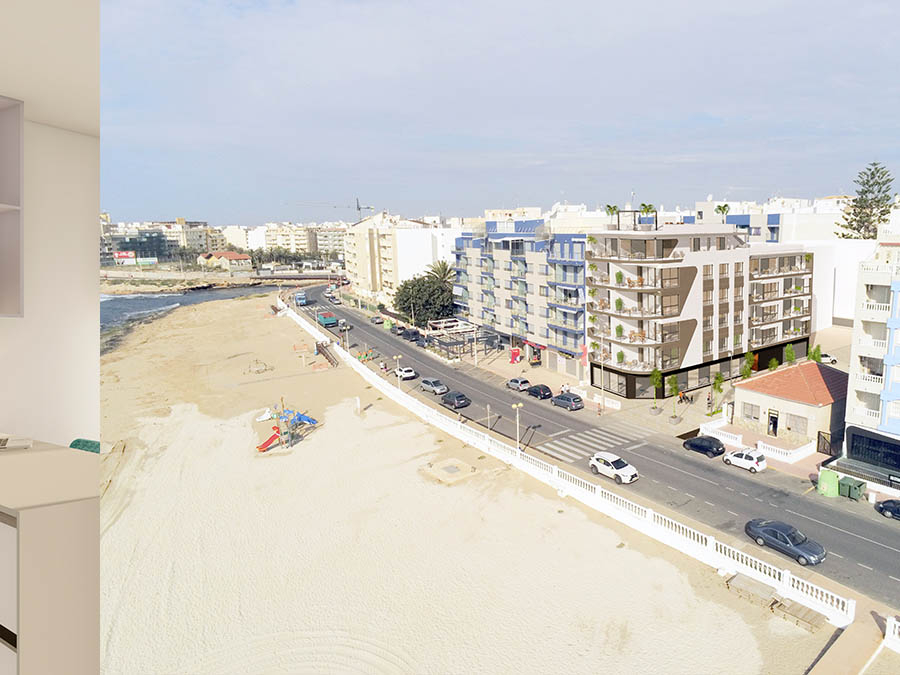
left=344, top=212, right=461, bottom=304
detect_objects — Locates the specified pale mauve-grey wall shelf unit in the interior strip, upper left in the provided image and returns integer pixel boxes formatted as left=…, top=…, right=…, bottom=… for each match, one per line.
left=0, top=96, right=24, bottom=317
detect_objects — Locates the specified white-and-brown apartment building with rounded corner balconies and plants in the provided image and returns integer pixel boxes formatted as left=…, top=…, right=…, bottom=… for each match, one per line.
left=587, top=211, right=814, bottom=398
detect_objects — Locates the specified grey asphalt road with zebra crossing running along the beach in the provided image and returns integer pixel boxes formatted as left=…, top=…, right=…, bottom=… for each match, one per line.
left=304, top=288, right=900, bottom=607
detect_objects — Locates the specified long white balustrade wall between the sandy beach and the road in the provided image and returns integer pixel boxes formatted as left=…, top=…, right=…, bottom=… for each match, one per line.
left=278, top=298, right=856, bottom=628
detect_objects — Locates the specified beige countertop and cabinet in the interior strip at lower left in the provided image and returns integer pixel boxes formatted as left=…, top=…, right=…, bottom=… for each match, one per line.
left=0, top=442, right=100, bottom=675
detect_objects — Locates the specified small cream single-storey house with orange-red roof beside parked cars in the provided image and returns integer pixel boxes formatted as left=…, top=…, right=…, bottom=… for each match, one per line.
left=733, top=361, right=848, bottom=443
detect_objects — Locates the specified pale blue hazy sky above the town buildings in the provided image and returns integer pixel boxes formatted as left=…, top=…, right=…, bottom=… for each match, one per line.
left=101, top=0, right=900, bottom=225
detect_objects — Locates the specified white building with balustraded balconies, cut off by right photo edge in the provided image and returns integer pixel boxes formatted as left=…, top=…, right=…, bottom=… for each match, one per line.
left=829, top=229, right=900, bottom=495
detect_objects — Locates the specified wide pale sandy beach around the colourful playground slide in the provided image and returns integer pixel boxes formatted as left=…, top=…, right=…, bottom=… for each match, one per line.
left=101, top=295, right=831, bottom=674
